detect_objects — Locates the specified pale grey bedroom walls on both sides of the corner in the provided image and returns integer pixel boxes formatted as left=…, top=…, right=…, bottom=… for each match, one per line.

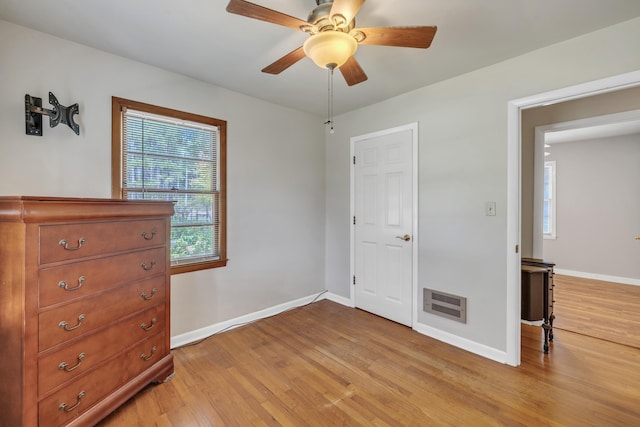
left=0, top=15, right=640, bottom=359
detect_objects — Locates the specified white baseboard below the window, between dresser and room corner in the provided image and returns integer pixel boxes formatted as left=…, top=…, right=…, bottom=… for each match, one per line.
left=171, top=291, right=327, bottom=348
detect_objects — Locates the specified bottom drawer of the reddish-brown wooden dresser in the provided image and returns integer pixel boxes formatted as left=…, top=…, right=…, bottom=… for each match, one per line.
left=38, top=333, right=167, bottom=426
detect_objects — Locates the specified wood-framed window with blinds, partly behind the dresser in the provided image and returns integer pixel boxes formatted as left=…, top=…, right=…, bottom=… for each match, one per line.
left=112, top=97, right=227, bottom=274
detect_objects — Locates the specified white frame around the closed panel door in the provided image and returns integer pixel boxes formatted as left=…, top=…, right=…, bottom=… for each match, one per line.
left=349, top=122, right=419, bottom=328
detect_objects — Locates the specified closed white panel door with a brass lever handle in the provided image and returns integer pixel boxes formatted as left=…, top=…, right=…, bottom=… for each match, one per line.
left=353, top=128, right=415, bottom=326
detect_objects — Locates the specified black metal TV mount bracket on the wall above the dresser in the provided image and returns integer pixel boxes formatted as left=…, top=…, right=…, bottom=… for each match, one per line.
left=24, top=92, right=80, bottom=136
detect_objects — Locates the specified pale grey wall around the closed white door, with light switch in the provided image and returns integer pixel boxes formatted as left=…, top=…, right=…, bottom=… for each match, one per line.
left=326, top=19, right=640, bottom=360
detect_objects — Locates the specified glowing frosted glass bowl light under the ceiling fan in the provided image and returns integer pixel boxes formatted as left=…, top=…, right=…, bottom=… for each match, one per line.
left=303, top=30, right=358, bottom=68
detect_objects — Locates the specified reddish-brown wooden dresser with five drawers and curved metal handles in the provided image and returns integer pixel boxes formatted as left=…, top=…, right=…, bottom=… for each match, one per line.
left=0, top=197, right=173, bottom=427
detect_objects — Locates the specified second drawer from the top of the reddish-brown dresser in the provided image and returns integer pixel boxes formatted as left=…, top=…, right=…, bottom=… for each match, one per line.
left=38, top=248, right=166, bottom=307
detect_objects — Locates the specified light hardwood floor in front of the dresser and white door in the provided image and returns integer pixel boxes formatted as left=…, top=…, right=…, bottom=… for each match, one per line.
left=100, top=300, right=640, bottom=427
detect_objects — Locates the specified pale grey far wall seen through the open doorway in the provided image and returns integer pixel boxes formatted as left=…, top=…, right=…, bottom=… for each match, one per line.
left=543, top=134, right=640, bottom=282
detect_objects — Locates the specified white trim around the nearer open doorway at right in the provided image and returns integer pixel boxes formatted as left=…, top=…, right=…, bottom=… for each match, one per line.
left=506, top=71, right=640, bottom=366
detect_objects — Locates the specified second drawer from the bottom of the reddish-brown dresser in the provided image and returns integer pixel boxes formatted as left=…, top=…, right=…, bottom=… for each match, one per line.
left=38, top=304, right=166, bottom=396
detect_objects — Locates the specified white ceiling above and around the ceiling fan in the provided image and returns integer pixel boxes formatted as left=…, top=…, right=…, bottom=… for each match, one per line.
left=0, top=0, right=640, bottom=115
